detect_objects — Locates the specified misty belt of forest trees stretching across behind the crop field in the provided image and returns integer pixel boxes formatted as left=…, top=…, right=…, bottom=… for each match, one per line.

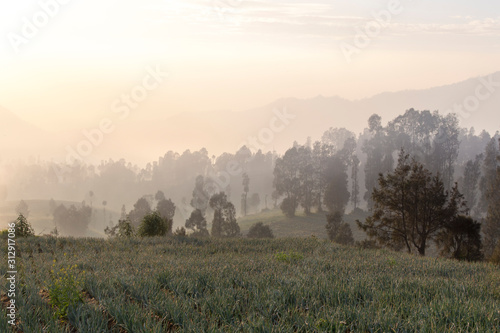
left=3, top=109, right=499, bottom=260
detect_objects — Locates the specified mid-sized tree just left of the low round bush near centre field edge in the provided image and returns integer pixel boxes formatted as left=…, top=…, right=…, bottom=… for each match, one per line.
left=209, top=192, right=240, bottom=237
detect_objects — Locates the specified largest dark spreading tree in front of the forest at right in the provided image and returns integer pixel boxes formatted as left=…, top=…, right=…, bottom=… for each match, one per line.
left=358, top=149, right=465, bottom=255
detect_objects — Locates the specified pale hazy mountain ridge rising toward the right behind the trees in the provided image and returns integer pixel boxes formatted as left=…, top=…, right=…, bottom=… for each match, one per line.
left=119, top=72, right=500, bottom=156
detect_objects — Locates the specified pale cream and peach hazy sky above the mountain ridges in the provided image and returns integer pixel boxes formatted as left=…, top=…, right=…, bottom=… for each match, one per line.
left=0, top=0, right=500, bottom=129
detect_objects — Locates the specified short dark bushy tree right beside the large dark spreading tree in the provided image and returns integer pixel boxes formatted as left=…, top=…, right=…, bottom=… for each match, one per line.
left=437, top=215, right=483, bottom=261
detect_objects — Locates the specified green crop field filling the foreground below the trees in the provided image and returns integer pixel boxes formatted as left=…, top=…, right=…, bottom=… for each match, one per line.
left=0, top=237, right=500, bottom=333
